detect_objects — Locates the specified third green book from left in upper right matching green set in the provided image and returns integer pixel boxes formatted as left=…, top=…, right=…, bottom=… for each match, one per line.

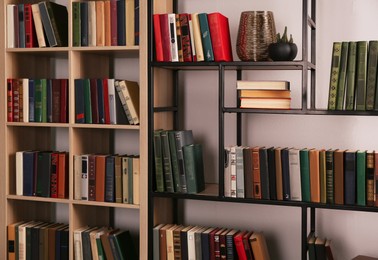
left=345, top=42, right=357, bottom=110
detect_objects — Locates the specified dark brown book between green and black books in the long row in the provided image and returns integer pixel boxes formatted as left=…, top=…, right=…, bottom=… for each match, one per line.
left=334, top=149, right=345, bottom=204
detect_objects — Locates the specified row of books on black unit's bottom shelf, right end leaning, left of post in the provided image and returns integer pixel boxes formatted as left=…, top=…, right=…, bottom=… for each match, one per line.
left=153, top=224, right=270, bottom=260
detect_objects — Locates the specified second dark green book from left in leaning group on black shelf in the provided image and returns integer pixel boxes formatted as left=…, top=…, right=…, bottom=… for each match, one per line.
left=160, top=130, right=176, bottom=192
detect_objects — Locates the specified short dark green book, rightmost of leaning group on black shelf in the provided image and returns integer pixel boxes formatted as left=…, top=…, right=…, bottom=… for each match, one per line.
left=182, top=144, right=205, bottom=193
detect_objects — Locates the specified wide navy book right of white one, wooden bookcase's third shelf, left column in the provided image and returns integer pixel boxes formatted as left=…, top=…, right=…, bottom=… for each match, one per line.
left=22, top=151, right=37, bottom=196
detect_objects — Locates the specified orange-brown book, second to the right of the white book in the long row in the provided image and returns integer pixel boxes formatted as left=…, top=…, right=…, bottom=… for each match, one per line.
left=309, top=149, right=320, bottom=202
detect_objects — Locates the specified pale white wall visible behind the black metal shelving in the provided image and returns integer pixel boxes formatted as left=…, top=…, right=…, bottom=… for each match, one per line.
left=179, top=0, right=378, bottom=260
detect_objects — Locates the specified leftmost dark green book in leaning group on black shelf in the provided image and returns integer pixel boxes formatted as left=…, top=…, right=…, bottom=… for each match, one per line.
left=154, top=130, right=165, bottom=192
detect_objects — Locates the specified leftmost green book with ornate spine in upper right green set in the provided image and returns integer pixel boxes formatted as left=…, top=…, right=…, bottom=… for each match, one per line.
left=328, top=42, right=341, bottom=110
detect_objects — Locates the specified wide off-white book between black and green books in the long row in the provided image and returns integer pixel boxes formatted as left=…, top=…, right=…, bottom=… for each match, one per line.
left=289, top=148, right=302, bottom=201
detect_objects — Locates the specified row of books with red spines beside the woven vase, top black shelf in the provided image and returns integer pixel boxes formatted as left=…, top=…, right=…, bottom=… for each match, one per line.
left=153, top=13, right=233, bottom=62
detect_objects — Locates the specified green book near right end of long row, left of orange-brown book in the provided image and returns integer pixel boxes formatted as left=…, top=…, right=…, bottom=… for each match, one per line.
left=356, top=150, right=366, bottom=206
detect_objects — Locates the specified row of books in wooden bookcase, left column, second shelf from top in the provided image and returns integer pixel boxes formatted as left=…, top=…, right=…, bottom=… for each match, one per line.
left=7, top=78, right=68, bottom=123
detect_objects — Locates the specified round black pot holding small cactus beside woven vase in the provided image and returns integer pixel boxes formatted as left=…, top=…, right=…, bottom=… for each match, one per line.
left=268, top=42, right=298, bottom=61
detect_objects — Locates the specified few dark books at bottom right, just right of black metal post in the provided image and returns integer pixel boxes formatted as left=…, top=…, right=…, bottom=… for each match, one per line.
left=307, top=232, right=334, bottom=260
